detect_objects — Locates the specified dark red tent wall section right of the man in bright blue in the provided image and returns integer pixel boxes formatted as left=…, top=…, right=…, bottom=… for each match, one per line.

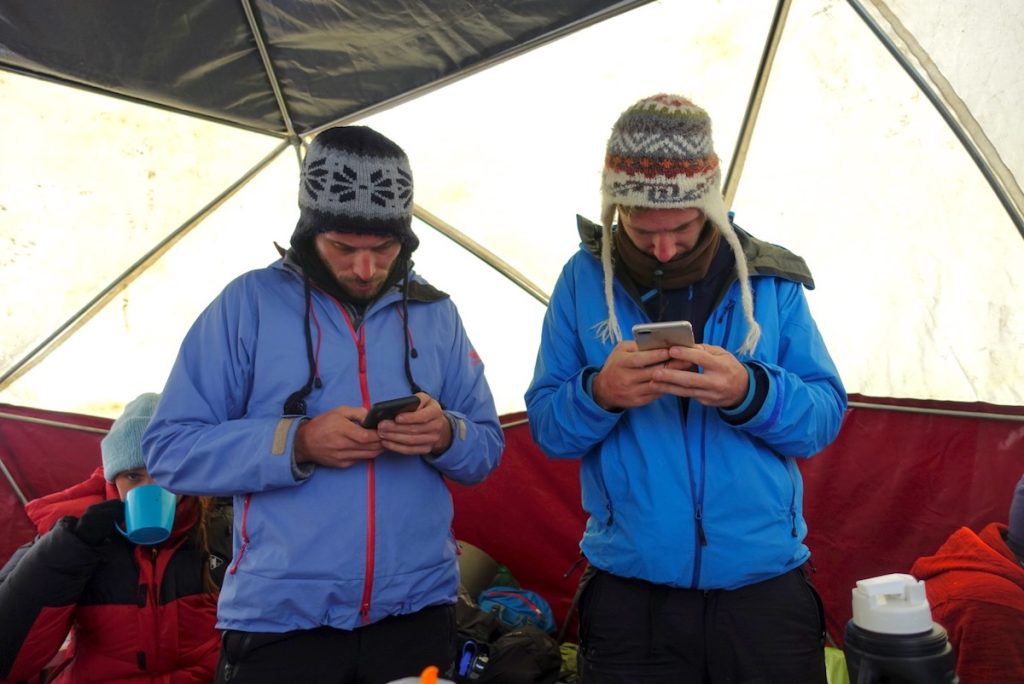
left=801, top=396, right=1024, bottom=643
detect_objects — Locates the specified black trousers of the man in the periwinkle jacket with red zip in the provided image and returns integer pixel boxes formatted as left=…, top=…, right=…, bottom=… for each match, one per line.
left=216, top=605, right=456, bottom=684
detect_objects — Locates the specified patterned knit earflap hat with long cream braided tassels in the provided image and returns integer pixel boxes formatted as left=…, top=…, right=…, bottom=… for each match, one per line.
left=598, top=94, right=761, bottom=353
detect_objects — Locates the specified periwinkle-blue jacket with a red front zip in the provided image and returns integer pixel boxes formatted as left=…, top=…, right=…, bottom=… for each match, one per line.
left=143, top=255, right=504, bottom=632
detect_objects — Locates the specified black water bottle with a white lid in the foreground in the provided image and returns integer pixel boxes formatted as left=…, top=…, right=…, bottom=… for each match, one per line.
left=844, top=573, right=959, bottom=684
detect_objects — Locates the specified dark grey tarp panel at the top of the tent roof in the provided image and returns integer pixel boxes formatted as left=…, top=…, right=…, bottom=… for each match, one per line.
left=0, top=0, right=630, bottom=135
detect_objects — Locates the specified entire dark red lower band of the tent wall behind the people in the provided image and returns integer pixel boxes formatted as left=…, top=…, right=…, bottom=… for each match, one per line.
left=0, top=395, right=1024, bottom=644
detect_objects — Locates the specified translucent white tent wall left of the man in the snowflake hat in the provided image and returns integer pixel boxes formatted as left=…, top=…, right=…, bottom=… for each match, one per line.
left=0, top=74, right=296, bottom=416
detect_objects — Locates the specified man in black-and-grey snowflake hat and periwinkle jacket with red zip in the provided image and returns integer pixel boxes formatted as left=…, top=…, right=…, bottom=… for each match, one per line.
left=143, top=126, right=504, bottom=684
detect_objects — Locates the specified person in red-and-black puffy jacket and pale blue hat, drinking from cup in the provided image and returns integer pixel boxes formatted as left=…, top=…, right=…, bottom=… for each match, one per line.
left=0, top=393, right=231, bottom=682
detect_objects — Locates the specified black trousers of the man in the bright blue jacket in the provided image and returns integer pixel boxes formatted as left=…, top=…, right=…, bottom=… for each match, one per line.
left=579, top=568, right=826, bottom=684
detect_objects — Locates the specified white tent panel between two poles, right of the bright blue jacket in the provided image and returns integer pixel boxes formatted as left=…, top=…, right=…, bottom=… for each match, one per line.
left=733, top=2, right=1024, bottom=404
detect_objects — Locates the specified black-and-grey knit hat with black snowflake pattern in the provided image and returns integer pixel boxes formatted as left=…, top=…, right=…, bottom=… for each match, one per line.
left=292, top=126, right=420, bottom=253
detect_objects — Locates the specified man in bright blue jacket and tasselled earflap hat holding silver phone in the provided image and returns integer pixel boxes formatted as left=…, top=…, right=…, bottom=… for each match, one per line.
left=526, top=94, right=847, bottom=684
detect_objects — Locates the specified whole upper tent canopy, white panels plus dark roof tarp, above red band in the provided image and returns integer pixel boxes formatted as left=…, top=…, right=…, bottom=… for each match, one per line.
left=0, top=0, right=1024, bottom=417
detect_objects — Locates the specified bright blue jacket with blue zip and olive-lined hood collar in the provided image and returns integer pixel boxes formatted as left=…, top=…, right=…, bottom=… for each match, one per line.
left=526, top=226, right=847, bottom=589
